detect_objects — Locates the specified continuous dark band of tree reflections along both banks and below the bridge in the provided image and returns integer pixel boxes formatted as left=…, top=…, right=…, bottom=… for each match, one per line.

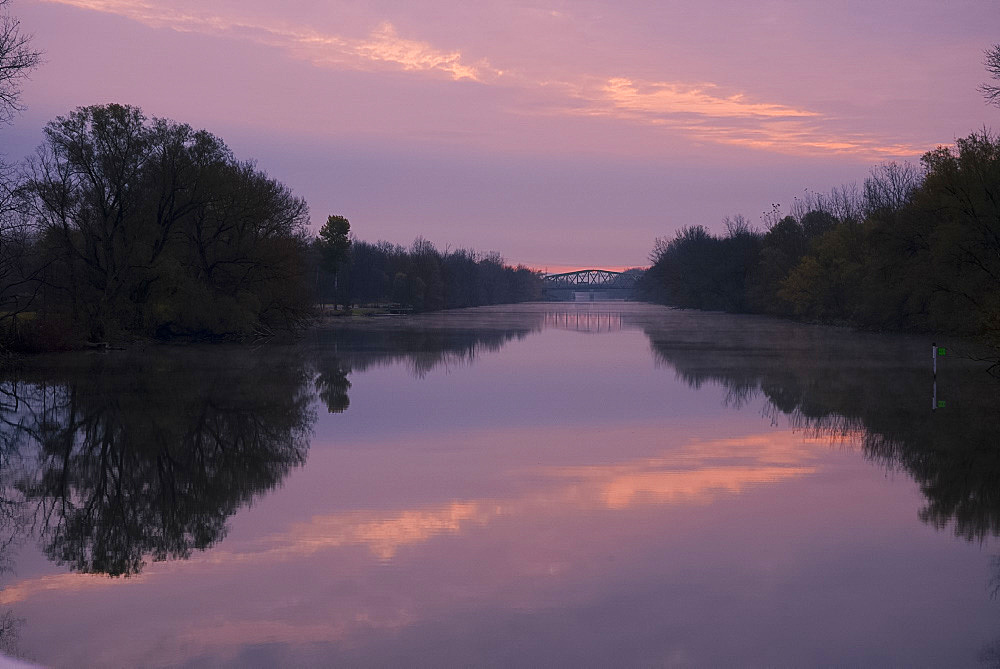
left=0, top=308, right=1000, bottom=575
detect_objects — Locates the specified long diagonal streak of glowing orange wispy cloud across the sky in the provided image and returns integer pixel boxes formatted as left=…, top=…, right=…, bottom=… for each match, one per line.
left=42, top=0, right=923, bottom=160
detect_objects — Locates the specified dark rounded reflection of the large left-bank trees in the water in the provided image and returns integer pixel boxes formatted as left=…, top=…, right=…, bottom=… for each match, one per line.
left=2, top=351, right=313, bottom=576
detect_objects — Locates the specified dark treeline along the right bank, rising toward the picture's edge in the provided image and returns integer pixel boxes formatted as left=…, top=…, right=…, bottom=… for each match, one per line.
left=641, top=130, right=1000, bottom=341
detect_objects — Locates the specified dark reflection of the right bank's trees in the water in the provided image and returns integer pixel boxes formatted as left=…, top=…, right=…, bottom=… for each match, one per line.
left=647, top=326, right=1000, bottom=541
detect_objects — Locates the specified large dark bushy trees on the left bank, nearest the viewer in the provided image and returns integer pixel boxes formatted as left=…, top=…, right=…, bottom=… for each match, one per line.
left=0, top=104, right=312, bottom=349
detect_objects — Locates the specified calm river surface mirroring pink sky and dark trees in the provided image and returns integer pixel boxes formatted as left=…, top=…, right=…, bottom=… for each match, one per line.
left=0, top=303, right=1000, bottom=667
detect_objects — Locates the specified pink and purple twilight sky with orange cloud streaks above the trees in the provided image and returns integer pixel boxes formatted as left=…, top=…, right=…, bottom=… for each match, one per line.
left=0, top=0, right=1000, bottom=271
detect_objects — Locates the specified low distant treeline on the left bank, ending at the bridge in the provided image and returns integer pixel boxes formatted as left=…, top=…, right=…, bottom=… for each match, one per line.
left=317, top=237, right=542, bottom=311
